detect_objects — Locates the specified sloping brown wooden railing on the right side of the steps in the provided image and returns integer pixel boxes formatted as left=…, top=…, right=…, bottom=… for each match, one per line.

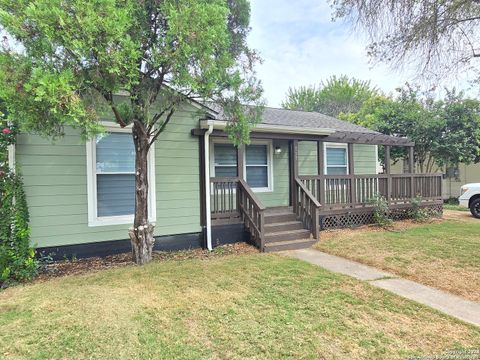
left=293, top=178, right=321, bottom=239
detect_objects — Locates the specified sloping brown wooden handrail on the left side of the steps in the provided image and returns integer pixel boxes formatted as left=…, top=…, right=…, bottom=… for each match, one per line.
left=237, top=179, right=266, bottom=251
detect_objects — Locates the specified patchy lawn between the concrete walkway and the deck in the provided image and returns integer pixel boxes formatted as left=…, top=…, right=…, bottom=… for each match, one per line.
left=316, top=211, right=480, bottom=301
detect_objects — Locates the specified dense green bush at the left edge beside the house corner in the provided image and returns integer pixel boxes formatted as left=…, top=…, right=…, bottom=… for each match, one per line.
left=0, top=170, right=37, bottom=287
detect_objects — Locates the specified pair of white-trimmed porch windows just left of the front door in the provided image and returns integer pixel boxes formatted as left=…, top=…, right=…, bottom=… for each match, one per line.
left=210, top=140, right=273, bottom=192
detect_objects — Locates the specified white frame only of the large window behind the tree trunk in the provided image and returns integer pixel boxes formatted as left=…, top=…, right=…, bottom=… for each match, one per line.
left=86, top=122, right=157, bottom=227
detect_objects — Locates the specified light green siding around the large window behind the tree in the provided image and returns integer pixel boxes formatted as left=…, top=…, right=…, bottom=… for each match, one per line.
left=16, top=108, right=201, bottom=247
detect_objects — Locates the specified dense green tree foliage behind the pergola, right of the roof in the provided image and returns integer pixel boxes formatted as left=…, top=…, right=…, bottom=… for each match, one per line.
left=341, top=86, right=480, bottom=172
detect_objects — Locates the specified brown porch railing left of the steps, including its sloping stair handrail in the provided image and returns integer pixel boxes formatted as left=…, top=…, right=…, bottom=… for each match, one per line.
left=210, top=177, right=266, bottom=251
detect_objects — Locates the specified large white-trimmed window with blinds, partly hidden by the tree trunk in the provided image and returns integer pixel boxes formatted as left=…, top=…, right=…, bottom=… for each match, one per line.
left=87, top=125, right=155, bottom=226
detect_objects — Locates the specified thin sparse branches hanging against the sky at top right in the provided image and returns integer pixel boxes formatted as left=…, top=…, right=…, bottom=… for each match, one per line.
left=330, top=0, right=480, bottom=82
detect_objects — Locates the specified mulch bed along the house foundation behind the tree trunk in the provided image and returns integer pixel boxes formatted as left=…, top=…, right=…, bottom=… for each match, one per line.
left=35, top=243, right=258, bottom=281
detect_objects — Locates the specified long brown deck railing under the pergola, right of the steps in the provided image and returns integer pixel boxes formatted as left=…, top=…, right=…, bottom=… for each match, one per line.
left=299, top=174, right=442, bottom=209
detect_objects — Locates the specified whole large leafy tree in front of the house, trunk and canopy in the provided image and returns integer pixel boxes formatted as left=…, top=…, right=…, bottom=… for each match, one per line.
left=0, top=0, right=262, bottom=264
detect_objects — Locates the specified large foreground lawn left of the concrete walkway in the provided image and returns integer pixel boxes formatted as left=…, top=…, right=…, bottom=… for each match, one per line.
left=0, top=254, right=480, bottom=359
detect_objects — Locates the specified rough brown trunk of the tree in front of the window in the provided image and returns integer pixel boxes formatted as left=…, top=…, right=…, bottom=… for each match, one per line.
left=128, top=121, right=155, bottom=265
